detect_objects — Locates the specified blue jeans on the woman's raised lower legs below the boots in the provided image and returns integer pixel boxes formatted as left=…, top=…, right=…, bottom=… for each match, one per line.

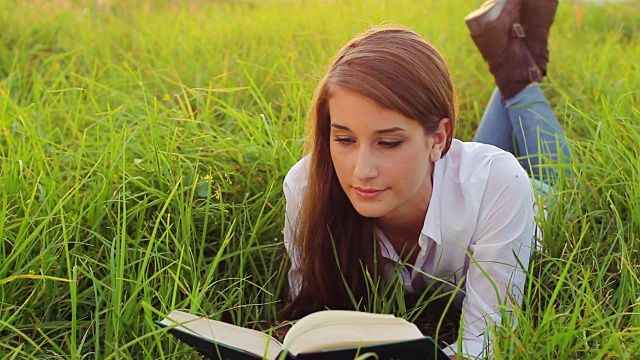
left=473, top=84, right=571, bottom=184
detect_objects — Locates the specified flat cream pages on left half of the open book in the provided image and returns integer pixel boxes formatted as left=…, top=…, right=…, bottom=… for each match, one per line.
left=160, top=310, right=283, bottom=359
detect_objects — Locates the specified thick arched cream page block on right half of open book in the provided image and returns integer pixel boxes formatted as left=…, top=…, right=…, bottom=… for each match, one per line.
left=284, top=310, right=424, bottom=355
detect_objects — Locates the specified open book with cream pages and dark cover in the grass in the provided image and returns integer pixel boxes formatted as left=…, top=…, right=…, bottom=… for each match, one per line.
left=156, top=310, right=448, bottom=360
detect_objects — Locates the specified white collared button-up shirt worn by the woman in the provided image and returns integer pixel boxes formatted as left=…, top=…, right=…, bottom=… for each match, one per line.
left=284, top=139, right=534, bottom=358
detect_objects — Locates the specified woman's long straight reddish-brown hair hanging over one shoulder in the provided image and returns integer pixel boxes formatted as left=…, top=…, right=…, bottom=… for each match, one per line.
left=283, top=26, right=457, bottom=318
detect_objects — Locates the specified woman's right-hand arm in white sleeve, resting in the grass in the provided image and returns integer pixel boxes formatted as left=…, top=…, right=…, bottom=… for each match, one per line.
left=454, top=156, right=534, bottom=356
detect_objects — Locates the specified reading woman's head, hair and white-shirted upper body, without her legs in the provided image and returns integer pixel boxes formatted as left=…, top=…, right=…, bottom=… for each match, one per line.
left=284, top=0, right=568, bottom=358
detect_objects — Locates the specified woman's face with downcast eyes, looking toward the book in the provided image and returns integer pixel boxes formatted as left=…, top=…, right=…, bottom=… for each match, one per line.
left=329, top=88, right=447, bottom=223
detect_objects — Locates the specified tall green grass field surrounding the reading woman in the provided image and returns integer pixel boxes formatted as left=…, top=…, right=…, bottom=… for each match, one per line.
left=0, top=0, right=640, bottom=359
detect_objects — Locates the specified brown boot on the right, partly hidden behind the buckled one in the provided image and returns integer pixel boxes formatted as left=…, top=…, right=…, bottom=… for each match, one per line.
left=520, top=0, right=558, bottom=76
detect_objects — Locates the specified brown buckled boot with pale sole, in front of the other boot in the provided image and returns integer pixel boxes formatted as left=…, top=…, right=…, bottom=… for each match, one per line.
left=464, top=0, right=542, bottom=99
